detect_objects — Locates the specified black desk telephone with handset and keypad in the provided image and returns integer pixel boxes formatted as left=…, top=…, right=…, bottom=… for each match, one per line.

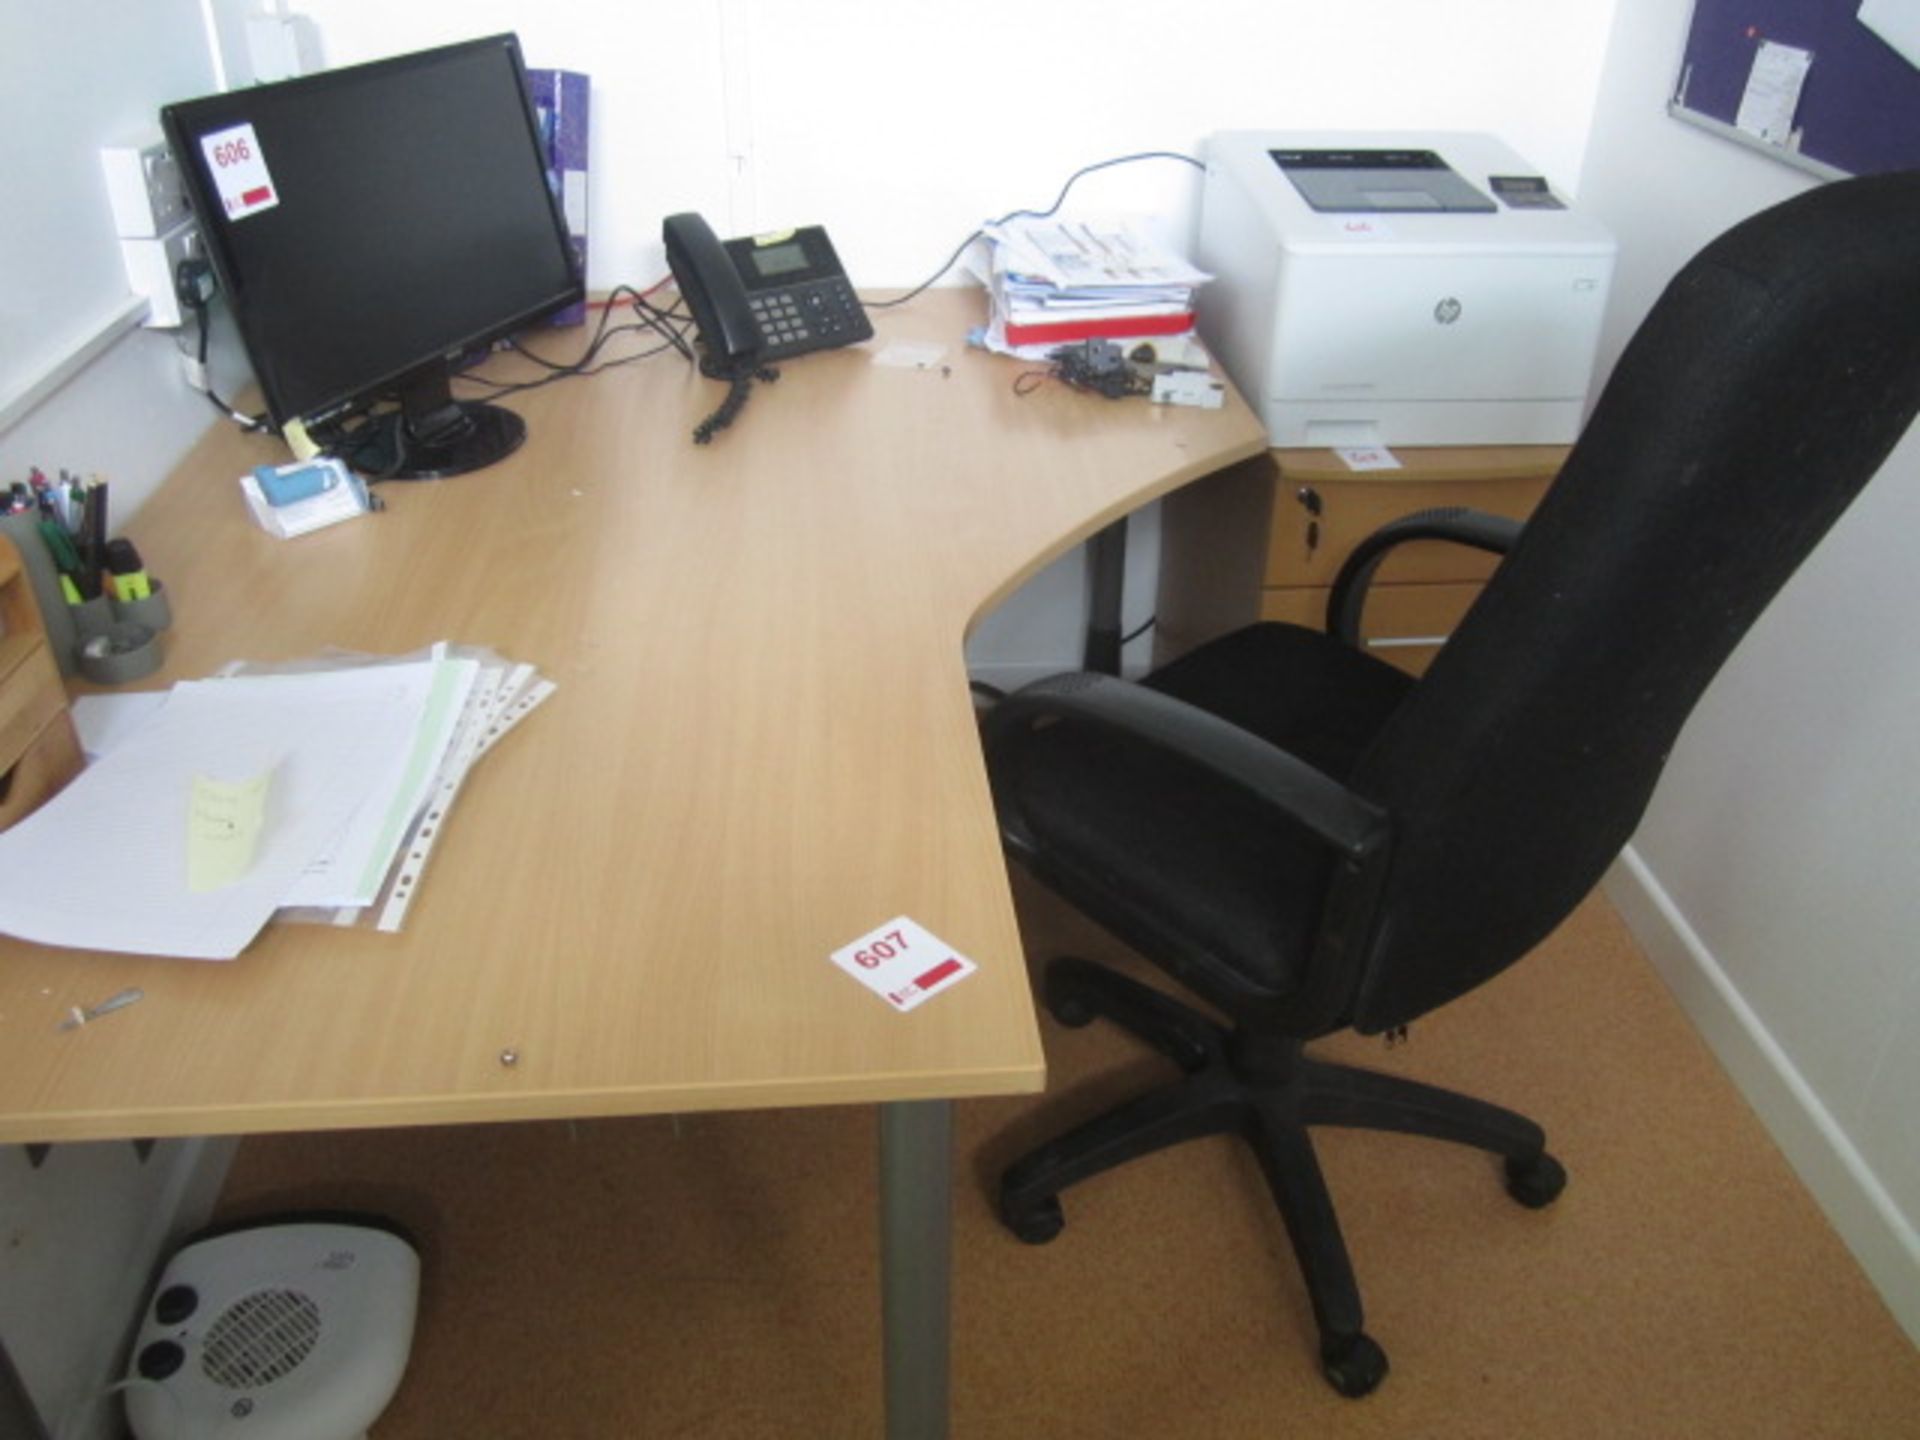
left=662, top=213, right=874, bottom=380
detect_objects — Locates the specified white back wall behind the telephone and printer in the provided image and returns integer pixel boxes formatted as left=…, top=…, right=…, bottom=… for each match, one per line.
left=274, top=0, right=1613, bottom=684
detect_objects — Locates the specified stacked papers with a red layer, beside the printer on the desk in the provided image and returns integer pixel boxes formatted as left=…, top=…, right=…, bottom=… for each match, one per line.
left=985, top=219, right=1210, bottom=357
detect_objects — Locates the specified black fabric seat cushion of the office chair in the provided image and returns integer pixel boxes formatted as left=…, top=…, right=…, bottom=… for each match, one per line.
left=996, top=624, right=1413, bottom=1008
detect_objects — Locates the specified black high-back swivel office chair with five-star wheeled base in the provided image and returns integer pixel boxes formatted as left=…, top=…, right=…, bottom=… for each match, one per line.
left=985, top=173, right=1920, bottom=1396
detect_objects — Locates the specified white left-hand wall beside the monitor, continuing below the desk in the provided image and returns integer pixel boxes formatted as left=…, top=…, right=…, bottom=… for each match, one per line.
left=0, top=0, right=243, bottom=1438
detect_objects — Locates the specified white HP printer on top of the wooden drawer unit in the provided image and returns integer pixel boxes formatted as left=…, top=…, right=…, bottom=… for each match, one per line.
left=1198, top=131, right=1615, bottom=445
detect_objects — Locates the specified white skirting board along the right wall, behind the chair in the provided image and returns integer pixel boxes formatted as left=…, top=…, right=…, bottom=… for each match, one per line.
left=1603, top=847, right=1920, bottom=1344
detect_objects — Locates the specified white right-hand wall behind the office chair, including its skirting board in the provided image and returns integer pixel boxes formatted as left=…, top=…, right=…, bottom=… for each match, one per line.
left=1582, top=0, right=1920, bottom=1340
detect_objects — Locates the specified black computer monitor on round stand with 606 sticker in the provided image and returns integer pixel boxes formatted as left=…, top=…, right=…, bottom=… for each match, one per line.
left=161, top=35, right=582, bottom=478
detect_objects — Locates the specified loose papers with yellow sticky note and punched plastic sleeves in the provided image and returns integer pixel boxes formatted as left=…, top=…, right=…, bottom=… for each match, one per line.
left=0, top=645, right=553, bottom=960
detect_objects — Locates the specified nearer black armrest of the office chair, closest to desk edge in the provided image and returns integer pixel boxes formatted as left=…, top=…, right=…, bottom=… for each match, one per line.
left=985, top=672, right=1386, bottom=860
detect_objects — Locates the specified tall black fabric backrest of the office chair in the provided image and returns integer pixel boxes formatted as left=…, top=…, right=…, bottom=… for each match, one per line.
left=1350, top=173, right=1920, bottom=1031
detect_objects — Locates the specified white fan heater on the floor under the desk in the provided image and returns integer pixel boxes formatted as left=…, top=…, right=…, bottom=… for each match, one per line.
left=127, top=1221, right=420, bottom=1440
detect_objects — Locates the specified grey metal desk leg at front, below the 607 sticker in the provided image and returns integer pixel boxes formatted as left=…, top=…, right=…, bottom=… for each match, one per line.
left=879, top=1100, right=952, bottom=1440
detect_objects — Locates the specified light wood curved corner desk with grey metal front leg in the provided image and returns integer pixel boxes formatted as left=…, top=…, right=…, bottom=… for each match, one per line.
left=0, top=290, right=1265, bottom=1436
